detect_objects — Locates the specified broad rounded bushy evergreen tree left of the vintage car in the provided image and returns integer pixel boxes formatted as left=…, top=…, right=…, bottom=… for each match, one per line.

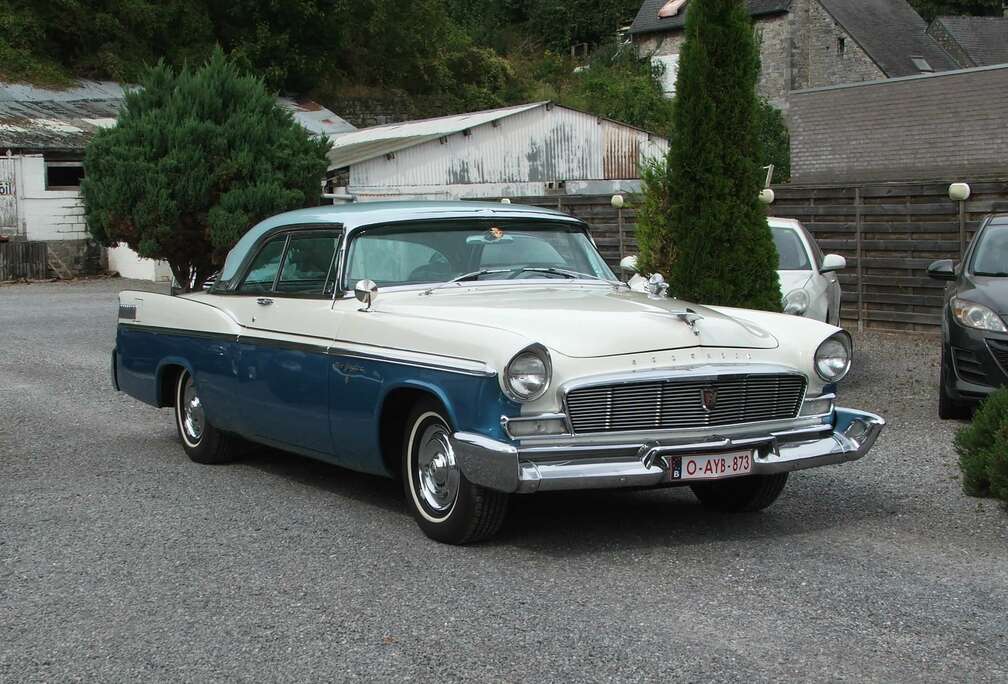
left=81, top=50, right=329, bottom=284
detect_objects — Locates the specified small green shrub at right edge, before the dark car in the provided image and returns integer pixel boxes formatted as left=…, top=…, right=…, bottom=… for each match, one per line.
left=956, top=388, right=1008, bottom=507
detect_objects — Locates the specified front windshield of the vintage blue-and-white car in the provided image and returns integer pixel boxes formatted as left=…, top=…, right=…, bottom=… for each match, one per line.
left=345, top=221, right=616, bottom=289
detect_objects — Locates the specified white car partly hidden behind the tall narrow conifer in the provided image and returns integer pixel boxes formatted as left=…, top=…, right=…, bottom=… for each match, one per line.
left=622, top=219, right=847, bottom=325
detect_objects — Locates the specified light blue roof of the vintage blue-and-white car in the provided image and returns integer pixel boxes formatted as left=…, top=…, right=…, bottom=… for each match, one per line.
left=221, top=200, right=582, bottom=280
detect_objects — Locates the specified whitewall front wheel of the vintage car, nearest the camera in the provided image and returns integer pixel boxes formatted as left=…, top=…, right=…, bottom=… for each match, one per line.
left=402, top=400, right=508, bottom=544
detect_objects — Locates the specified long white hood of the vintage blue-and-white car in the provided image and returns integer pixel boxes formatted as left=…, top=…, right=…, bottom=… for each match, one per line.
left=373, top=284, right=778, bottom=358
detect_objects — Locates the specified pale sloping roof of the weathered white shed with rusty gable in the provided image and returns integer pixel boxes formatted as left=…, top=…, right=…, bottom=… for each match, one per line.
left=329, top=102, right=548, bottom=168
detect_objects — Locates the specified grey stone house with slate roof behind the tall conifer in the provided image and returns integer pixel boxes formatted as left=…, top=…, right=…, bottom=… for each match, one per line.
left=630, top=0, right=958, bottom=111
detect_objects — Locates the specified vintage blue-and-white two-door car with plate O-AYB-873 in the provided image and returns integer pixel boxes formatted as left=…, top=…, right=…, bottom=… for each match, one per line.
left=112, top=202, right=884, bottom=543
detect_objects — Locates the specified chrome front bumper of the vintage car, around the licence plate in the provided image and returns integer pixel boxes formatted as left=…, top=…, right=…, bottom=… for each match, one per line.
left=452, top=408, right=885, bottom=494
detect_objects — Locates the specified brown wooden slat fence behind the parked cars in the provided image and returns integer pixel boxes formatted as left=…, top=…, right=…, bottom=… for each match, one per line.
left=515, top=179, right=1008, bottom=330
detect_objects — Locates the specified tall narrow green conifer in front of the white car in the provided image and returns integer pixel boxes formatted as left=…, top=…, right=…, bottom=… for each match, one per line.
left=638, top=0, right=780, bottom=311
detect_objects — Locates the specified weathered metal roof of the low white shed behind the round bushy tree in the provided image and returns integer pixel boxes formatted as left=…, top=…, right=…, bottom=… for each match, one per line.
left=0, top=81, right=356, bottom=151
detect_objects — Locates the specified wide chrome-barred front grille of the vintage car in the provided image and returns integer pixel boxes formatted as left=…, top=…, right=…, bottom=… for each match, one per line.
left=566, top=374, right=805, bottom=433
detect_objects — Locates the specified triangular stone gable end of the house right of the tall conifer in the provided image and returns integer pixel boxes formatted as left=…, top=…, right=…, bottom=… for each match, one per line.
left=788, top=0, right=886, bottom=91
